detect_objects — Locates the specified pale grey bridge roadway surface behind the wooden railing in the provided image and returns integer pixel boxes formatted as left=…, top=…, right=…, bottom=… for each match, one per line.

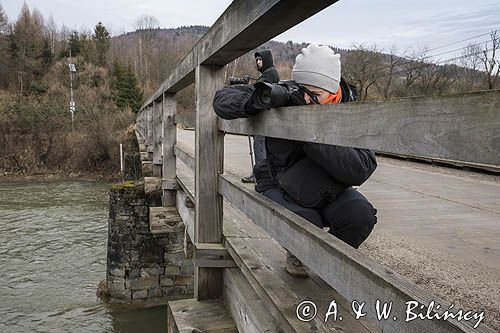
left=177, top=130, right=500, bottom=326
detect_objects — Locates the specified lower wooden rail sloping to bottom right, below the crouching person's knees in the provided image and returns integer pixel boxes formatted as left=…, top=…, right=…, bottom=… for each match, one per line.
left=219, top=175, right=493, bottom=332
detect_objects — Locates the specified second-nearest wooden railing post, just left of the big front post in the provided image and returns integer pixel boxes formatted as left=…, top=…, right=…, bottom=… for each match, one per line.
left=161, top=94, right=177, bottom=207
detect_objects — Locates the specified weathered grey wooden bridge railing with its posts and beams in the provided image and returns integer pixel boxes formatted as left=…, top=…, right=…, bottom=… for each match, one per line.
left=137, top=0, right=500, bottom=332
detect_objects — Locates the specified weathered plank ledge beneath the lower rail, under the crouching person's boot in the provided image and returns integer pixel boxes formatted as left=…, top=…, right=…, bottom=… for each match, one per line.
left=224, top=207, right=380, bottom=333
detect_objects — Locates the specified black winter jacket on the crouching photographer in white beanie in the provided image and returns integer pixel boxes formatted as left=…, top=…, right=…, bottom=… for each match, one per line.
left=213, top=79, right=377, bottom=192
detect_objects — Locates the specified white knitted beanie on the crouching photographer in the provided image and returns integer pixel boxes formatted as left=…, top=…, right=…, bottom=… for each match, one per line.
left=292, top=44, right=340, bottom=93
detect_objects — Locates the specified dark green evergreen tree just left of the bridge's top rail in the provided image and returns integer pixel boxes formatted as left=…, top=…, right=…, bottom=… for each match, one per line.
left=112, top=61, right=144, bottom=113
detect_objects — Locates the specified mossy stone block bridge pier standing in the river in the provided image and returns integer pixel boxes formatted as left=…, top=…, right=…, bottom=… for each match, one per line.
left=106, top=178, right=193, bottom=303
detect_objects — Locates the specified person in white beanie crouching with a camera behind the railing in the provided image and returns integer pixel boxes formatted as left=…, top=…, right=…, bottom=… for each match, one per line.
left=213, top=44, right=377, bottom=277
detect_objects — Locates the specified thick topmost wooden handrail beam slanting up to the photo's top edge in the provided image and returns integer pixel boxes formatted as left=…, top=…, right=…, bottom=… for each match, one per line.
left=142, top=0, right=337, bottom=108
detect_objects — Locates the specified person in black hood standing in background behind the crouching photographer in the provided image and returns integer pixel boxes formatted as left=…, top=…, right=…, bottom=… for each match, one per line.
left=241, top=49, right=280, bottom=183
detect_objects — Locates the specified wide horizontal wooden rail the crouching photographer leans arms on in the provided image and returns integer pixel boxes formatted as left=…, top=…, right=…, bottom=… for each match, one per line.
left=219, top=90, right=500, bottom=169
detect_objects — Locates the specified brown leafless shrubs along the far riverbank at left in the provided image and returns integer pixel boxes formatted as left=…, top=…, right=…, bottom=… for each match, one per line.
left=0, top=96, right=135, bottom=173
